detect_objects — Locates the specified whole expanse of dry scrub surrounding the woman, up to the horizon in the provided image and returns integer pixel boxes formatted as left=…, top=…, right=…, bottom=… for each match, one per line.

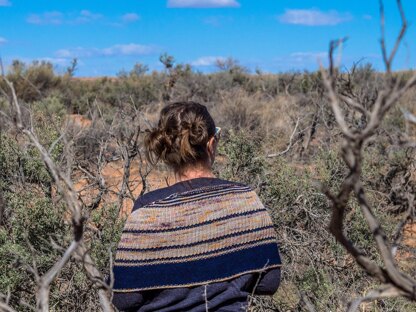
left=0, top=1, right=416, bottom=312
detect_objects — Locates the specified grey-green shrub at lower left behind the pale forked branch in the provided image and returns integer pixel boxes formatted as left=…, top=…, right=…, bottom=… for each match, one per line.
left=0, top=191, right=124, bottom=311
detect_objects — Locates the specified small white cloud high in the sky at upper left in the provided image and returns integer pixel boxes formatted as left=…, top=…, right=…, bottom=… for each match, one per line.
left=26, top=10, right=103, bottom=25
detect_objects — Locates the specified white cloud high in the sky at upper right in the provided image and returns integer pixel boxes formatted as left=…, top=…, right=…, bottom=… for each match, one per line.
left=278, top=9, right=352, bottom=26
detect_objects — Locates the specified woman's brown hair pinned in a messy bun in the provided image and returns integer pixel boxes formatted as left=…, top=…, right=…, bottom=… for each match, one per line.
left=145, top=102, right=215, bottom=171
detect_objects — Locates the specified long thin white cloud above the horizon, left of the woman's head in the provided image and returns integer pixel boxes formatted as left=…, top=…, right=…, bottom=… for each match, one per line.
left=55, top=43, right=155, bottom=58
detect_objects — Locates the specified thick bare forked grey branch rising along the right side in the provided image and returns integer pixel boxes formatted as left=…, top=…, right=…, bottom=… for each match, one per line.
left=321, top=0, right=416, bottom=311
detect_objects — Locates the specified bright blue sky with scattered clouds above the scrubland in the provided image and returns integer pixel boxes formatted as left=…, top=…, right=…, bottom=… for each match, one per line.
left=0, top=0, right=416, bottom=76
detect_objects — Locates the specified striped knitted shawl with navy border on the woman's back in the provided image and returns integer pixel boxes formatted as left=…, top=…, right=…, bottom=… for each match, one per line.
left=113, top=183, right=280, bottom=292
